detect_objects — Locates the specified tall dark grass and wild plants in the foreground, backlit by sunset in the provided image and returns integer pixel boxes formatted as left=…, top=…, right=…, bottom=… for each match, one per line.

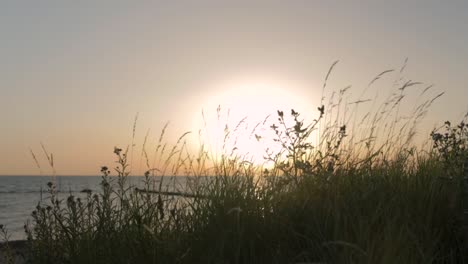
left=3, top=60, right=468, bottom=263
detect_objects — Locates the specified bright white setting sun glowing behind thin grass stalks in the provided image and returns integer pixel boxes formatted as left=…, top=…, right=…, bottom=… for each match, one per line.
left=193, top=77, right=311, bottom=167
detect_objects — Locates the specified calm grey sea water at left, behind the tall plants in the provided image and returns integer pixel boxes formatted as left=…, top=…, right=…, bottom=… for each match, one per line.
left=0, top=176, right=187, bottom=241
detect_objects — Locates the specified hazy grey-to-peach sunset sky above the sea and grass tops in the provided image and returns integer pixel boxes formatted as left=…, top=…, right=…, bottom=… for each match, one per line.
left=0, top=0, right=468, bottom=175
